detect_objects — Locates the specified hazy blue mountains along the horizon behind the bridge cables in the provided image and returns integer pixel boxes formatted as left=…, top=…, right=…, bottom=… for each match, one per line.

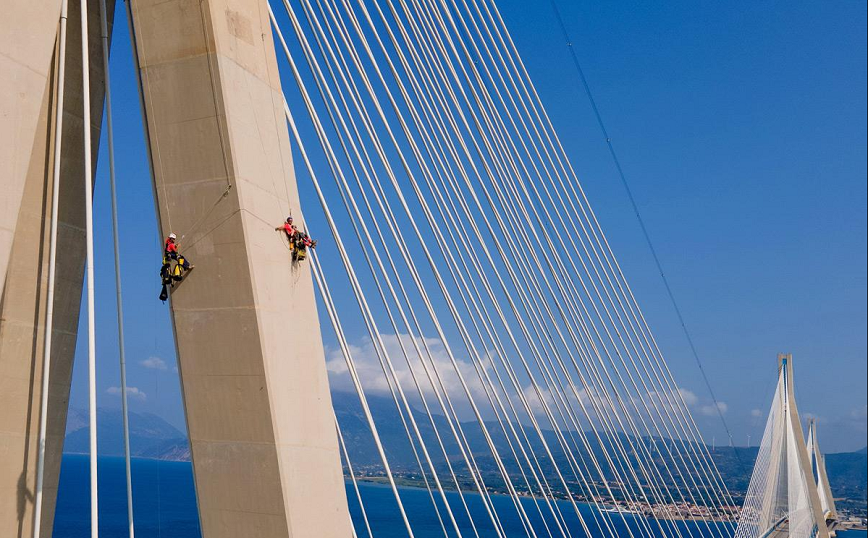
left=64, top=392, right=868, bottom=503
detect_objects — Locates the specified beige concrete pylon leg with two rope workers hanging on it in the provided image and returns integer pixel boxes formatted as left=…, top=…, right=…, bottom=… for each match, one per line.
left=131, top=0, right=352, bottom=538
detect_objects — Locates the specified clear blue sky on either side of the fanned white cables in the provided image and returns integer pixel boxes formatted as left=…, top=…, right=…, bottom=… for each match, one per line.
left=72, top=0, right=866, bottom=451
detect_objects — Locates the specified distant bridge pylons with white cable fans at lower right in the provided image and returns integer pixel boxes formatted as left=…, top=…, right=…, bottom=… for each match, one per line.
left=735, top=353, right=835, bottom=538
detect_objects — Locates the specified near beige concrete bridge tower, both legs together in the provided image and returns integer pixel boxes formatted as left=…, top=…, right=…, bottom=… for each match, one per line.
left=0, top=0, right=352, bottom=538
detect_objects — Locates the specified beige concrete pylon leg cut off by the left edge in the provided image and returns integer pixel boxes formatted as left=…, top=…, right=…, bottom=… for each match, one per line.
left=0, top=0, right=112, bottom=538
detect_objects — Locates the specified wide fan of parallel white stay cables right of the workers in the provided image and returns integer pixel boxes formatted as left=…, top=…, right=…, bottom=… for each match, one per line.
left=269, top=0, right=736, bottom=538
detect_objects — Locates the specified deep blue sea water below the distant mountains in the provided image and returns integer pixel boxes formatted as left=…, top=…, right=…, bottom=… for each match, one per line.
left=54, top=454, right=866, bottom=538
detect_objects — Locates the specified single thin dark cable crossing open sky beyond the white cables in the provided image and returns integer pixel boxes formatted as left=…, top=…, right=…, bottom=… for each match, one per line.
left=549, top=0, right=742, bottom=464
